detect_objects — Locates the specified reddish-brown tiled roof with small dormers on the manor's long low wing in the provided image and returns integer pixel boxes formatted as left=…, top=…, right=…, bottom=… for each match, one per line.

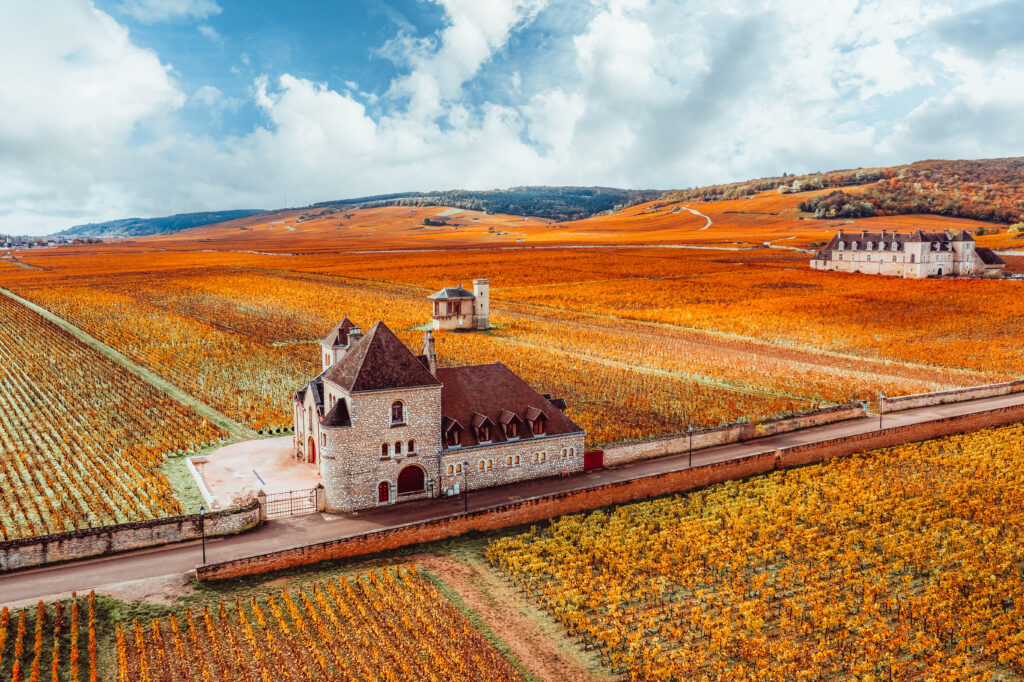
left=437, top=363, right=583, bottom=445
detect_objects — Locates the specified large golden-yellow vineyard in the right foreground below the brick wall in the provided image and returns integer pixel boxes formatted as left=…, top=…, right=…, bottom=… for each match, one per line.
left=487, top=424, right=1024, bottom=680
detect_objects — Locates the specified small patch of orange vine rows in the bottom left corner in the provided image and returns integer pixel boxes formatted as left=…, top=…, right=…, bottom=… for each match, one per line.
left=0, top=593, right=99, bottom=682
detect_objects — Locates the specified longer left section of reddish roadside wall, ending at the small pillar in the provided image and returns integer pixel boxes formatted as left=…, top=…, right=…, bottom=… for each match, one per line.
left=196, top=451, right=776, bottom=581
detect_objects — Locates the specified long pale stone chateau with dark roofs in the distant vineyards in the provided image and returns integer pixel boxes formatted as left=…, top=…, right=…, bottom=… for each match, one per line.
left=811, top=229, right=1007, bottom=278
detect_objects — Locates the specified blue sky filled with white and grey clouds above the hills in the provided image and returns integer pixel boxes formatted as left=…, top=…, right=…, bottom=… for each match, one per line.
left=0, top=0, right=1024, bottom=235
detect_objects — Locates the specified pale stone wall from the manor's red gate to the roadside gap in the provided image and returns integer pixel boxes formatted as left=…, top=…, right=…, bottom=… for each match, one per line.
left=604, top=402, right=864, bottom=466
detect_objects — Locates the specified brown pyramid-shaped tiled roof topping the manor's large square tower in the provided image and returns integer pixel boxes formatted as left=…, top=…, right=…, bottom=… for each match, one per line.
left=324, top=322, right=438, bottom=393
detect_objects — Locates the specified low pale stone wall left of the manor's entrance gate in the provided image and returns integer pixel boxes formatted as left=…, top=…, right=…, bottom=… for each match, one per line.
left=0, top=502, right=260, bottom=572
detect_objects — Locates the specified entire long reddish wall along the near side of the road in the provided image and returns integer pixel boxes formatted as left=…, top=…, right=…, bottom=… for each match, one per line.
left=197, top=404, right=1024, bottom=580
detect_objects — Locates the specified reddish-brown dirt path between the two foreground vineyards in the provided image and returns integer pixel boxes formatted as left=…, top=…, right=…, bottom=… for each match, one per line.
left=412, top=554, right=616, bottom=682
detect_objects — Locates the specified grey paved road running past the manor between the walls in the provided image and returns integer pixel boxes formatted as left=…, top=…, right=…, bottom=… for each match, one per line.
left=0, top=393, right=1024, bottom=605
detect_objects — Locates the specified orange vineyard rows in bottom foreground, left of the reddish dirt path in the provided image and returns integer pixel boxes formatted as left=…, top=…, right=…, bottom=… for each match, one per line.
left=116, top=566, right=519, bottom=682
